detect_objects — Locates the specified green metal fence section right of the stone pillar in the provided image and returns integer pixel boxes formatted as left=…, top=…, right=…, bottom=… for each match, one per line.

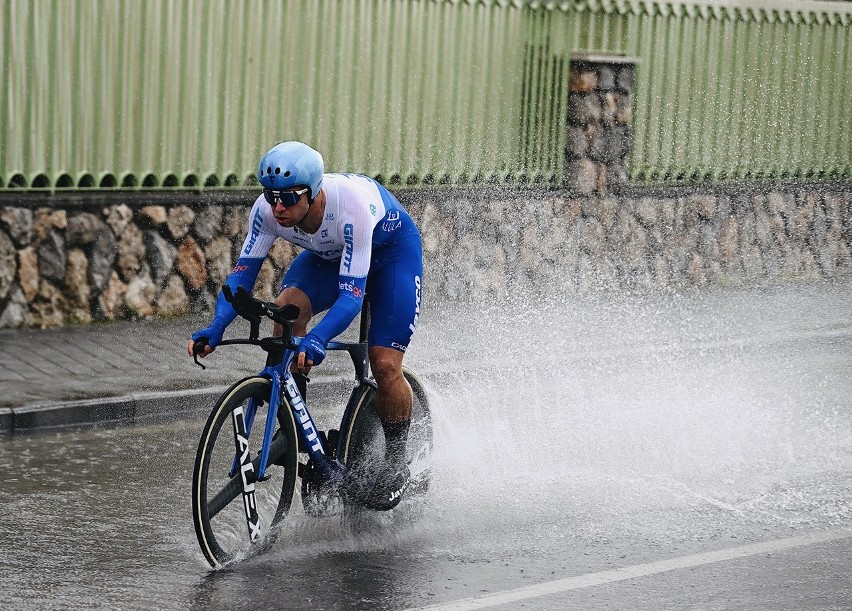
left=627, top=2, right=852, bottom=180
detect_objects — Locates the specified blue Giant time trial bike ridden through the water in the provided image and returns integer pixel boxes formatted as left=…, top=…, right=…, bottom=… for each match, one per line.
left=192, top=286, right=432, bottom=568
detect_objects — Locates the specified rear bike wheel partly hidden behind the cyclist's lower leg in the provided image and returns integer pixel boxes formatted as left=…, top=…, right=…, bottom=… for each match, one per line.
left=340, top=367, right=432, bottom=516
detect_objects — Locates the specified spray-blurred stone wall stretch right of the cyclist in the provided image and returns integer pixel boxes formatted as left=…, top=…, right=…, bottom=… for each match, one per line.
left=410, top=188, right=852, bottom=299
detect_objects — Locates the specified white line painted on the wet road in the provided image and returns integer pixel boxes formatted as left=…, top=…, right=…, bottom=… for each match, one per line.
left=420, top=528, right=852, bottom=611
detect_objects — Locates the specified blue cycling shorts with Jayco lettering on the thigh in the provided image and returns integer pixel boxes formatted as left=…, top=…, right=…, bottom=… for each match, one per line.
left=281, top=231, right=423, bottom=352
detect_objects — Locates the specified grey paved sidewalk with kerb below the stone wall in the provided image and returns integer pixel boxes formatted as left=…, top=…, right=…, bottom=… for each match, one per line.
left=0, top=316, right=346, bottom=434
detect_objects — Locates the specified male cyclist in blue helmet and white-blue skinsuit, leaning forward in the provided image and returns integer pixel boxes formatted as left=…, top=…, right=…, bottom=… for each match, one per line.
left=187, top=142, right=423, bottom=509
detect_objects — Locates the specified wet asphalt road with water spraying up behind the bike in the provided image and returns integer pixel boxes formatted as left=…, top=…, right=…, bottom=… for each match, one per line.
left=0, top=283, right=852, bottom=609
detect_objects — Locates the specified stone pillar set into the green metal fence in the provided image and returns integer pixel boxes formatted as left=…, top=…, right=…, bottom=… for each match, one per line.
left=564, top=54, right=638, bottom=195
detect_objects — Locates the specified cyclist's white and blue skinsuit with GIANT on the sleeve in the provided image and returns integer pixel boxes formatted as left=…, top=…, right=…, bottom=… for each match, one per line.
left=207, top=174, right=423, bottom=351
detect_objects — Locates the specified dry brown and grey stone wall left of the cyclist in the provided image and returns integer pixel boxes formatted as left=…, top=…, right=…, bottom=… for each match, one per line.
left=0, top=202, right=295, bottom=328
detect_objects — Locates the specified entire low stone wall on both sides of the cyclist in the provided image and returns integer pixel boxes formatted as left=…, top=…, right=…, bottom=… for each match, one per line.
left=0, top=186, right=852, bottom=327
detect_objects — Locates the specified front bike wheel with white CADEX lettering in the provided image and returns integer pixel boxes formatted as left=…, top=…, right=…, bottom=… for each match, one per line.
left=192, top=377, right=299, bottom=567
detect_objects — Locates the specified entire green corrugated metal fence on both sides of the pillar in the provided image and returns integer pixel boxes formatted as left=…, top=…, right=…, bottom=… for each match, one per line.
left=0, top=0, right=852, bottom=190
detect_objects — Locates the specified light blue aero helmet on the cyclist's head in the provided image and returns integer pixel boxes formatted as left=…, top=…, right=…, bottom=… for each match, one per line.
left=257, top=141, right=325, bottom=200
